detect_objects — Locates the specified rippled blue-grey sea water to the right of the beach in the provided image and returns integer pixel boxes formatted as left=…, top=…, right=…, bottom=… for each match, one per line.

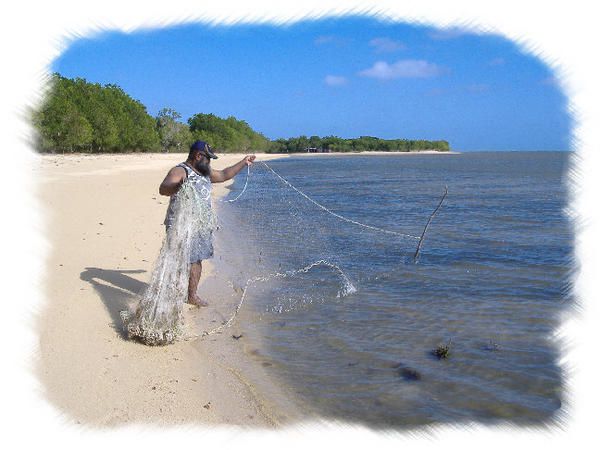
left=216, top=152, right=574, bottom=427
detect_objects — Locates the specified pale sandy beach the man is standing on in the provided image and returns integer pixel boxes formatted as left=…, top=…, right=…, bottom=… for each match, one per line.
left=34, top=154, right=297, bottom=427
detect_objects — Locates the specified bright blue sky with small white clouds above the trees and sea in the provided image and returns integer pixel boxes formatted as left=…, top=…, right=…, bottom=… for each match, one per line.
left=52, top=17, right=572, bottom=151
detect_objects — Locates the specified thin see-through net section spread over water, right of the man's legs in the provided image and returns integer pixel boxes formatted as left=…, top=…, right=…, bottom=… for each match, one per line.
left=202, top=161, right=434, bottom=335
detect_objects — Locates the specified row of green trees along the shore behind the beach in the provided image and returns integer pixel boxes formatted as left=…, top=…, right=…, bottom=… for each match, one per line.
left=32, top=73, right=450, bottom=153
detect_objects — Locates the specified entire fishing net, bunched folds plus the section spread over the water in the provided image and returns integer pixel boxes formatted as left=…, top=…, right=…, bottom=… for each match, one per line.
left=122, top=162, right=443, bottom=345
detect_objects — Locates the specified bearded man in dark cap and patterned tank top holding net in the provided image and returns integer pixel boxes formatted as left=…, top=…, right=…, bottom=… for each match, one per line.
left=158, top=141, right=256, bottom=306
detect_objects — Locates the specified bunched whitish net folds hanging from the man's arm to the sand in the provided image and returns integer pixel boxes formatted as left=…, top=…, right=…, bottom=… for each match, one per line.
left=121, top=180, right=215, bottom=345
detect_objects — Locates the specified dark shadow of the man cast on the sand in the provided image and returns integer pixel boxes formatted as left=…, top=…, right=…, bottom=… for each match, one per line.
left=79, top=267, right=148, bottom=337
